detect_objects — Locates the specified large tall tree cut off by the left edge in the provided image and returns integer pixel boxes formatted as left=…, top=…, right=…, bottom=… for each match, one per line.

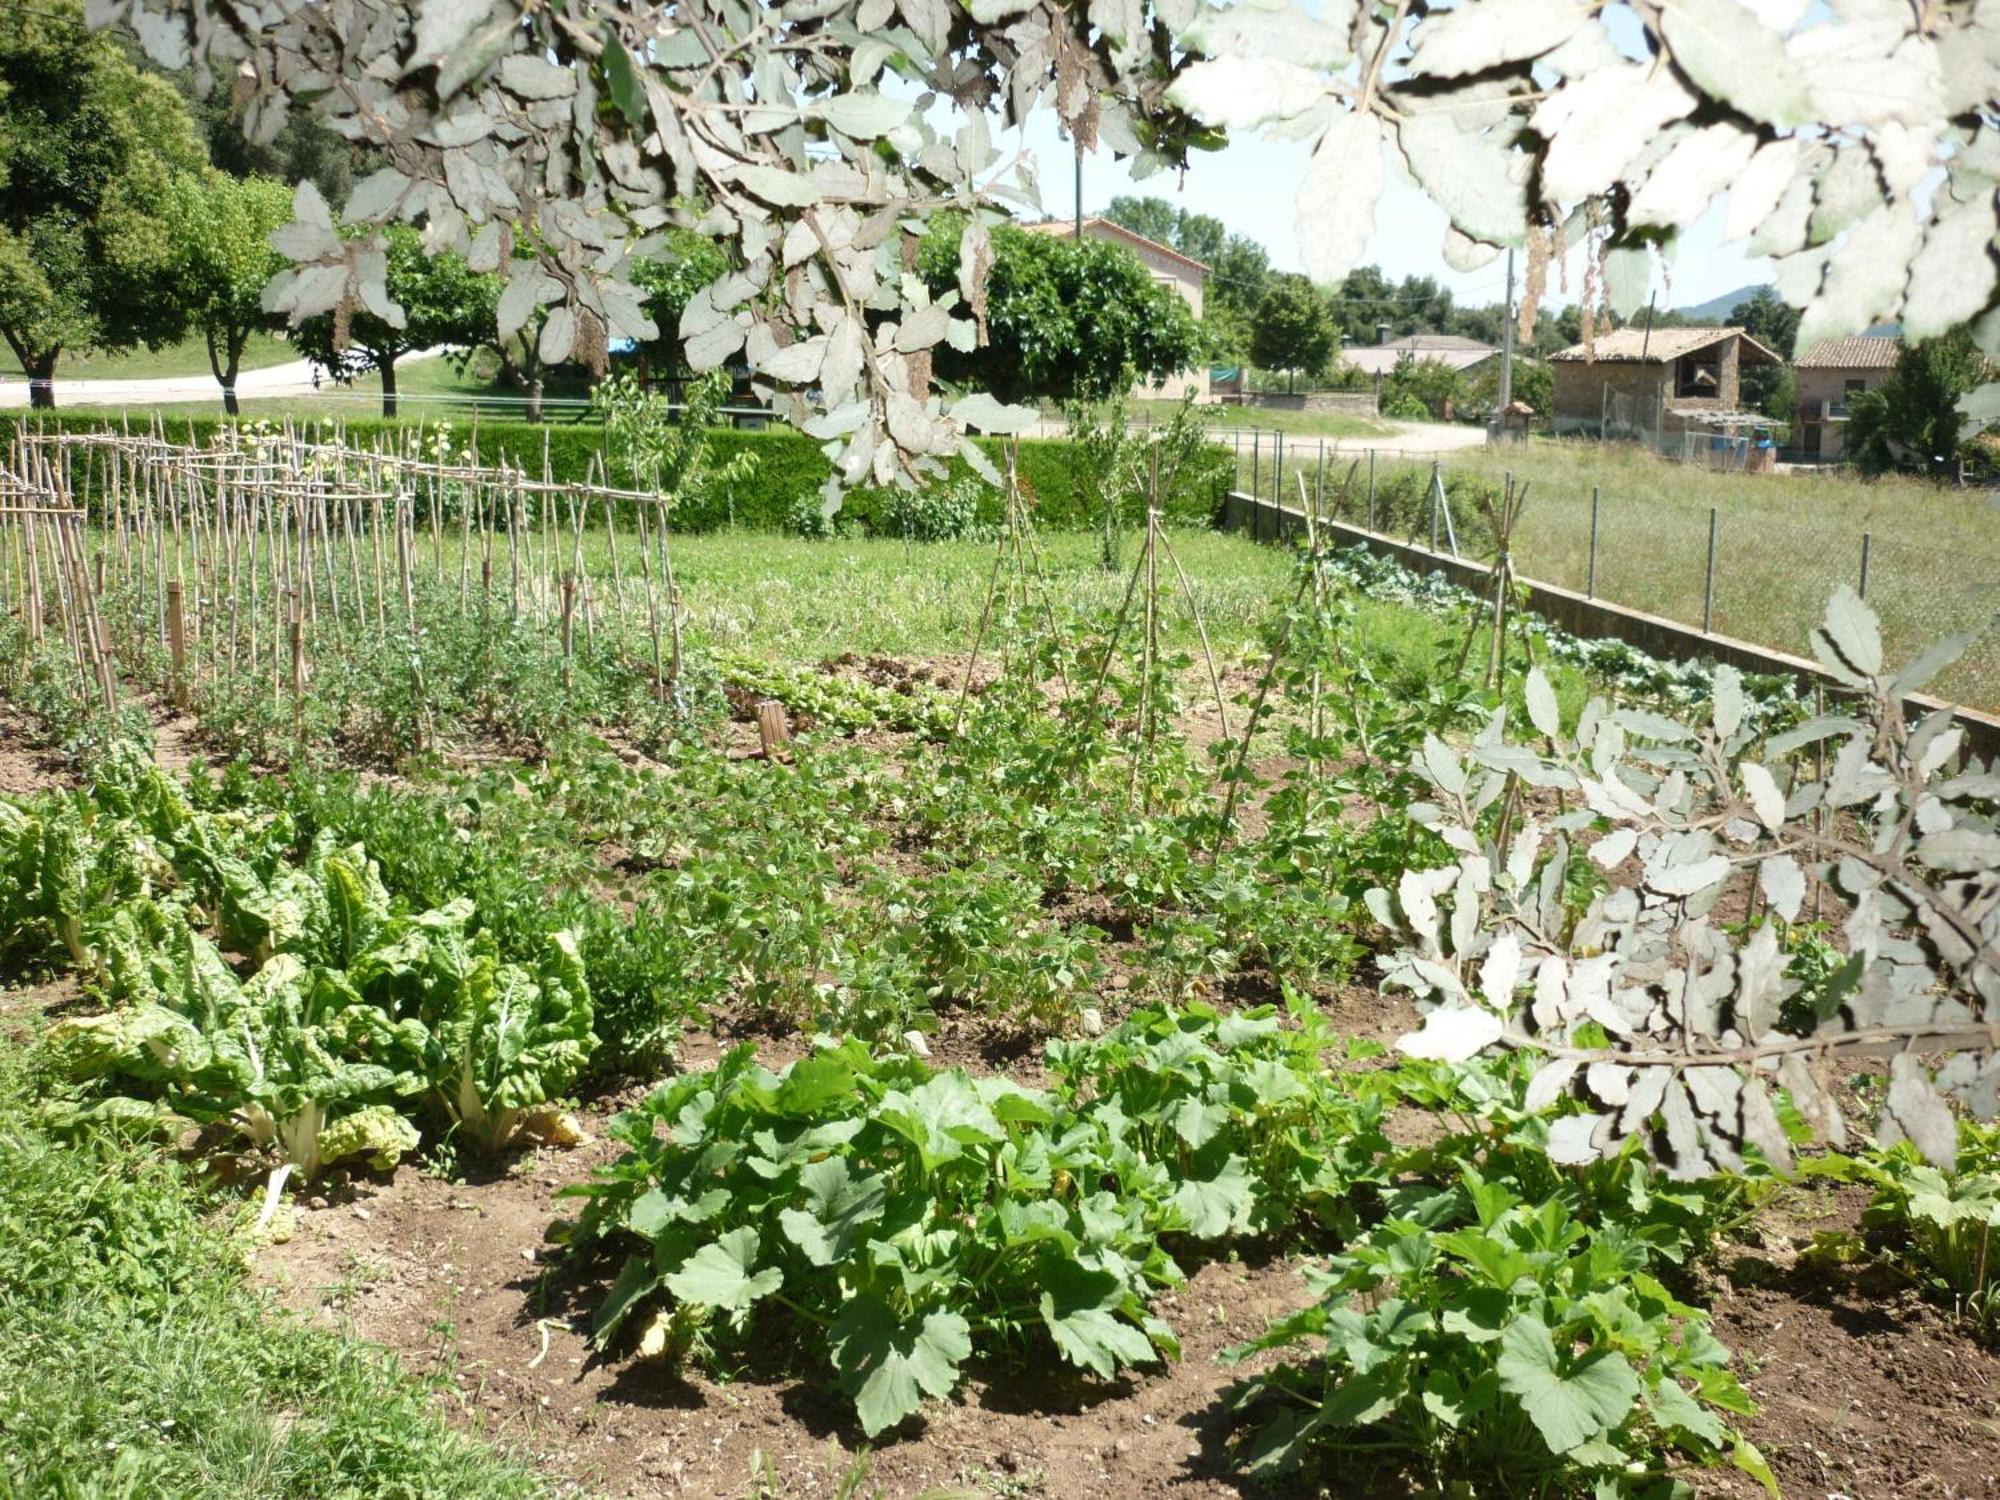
left=0, top=0, right=204, bottom=406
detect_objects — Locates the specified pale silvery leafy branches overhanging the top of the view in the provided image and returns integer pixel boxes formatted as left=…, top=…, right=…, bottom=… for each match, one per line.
left=104, top=0, right=2000, bottom=482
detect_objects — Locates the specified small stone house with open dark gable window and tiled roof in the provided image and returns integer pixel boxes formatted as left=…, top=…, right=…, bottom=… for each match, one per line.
left=1548, top=328, right=1784, bottom=438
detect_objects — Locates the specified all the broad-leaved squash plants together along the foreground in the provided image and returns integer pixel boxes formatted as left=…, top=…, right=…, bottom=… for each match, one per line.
left=556, top=1002, right=1770, bottom=1494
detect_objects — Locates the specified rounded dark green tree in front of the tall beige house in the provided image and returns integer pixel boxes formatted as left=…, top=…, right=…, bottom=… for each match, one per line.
left=918, top=216, right=1208, bottom=402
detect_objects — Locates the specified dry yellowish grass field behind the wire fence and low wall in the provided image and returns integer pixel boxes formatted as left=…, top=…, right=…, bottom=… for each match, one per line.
left=1244, top=440, right=2000, bottom=708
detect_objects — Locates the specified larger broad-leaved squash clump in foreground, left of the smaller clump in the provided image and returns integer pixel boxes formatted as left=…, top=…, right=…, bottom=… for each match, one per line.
left=568, top=1006, right=1386, bottom=1436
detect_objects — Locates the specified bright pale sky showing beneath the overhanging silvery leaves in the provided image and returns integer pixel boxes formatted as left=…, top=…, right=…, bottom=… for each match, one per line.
left=996, top=110, right=1770, bottom=308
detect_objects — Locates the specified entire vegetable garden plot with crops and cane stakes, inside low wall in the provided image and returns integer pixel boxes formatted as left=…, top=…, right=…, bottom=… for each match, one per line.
left=0, top=420, right=2000, bottom=1496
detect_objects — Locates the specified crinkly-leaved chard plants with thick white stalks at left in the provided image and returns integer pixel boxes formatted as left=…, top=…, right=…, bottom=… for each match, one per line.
left=0, top=758, right=596, bottom=1178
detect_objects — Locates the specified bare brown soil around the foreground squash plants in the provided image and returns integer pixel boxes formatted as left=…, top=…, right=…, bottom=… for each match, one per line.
left=258, top=1012, right=2000, bottom=1500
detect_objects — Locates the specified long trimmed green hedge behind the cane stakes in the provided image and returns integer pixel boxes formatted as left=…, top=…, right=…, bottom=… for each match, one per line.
left=0, top=410, right=1230, bottom=532
